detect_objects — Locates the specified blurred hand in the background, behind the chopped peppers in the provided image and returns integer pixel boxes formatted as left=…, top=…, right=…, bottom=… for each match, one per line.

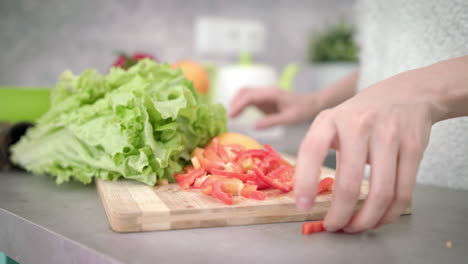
left=229, top=87, right=321, bottom=128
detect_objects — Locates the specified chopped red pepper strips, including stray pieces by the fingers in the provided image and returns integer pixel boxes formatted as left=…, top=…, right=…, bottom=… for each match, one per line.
left=175, top=137, right=334, bottom=234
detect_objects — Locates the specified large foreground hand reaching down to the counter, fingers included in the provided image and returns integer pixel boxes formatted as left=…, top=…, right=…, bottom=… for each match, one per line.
left=294, top=68, right=440, bottom=232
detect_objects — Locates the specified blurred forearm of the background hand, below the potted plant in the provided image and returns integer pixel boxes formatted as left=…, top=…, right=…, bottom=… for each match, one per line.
left=315, top=71, right=359, bottom=110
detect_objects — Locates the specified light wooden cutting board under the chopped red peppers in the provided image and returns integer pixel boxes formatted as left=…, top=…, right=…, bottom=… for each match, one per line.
left=96, top=156, right=411, bottom=232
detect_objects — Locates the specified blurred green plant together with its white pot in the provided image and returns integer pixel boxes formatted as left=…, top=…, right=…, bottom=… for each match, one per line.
left=308, top=20, right=358, bottom=89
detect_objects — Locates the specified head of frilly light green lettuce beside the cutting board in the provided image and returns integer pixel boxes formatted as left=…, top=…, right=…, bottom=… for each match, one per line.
left=11, top=59, right=227, bottom=185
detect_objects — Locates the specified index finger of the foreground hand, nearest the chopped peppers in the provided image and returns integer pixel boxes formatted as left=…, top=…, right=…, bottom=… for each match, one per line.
left=294, top=112, right=336, bottom=211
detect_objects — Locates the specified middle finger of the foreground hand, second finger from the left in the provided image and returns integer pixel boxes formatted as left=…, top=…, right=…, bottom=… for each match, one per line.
left=325, top=125, right=367, bottom=232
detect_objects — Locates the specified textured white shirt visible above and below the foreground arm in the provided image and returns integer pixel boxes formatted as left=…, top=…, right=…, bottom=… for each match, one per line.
left=356, top=0, right=468, bottom=190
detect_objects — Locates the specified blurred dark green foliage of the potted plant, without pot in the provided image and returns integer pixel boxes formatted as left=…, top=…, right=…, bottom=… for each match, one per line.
left=309, top=20, right=358, bottom=63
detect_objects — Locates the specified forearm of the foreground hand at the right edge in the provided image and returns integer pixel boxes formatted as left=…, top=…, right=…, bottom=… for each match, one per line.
left=420, top=55, right=468, bottom=122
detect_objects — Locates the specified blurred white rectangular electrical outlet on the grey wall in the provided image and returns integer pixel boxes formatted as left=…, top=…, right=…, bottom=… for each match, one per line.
left=195, top=17, right=265, bottom=55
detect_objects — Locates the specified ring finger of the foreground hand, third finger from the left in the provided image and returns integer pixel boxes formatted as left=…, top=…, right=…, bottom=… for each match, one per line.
left=345, top=128, right=399, bottom=233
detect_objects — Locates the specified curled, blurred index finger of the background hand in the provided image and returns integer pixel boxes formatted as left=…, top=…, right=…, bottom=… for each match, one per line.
left=229, top=88, right=281, bottom=117
